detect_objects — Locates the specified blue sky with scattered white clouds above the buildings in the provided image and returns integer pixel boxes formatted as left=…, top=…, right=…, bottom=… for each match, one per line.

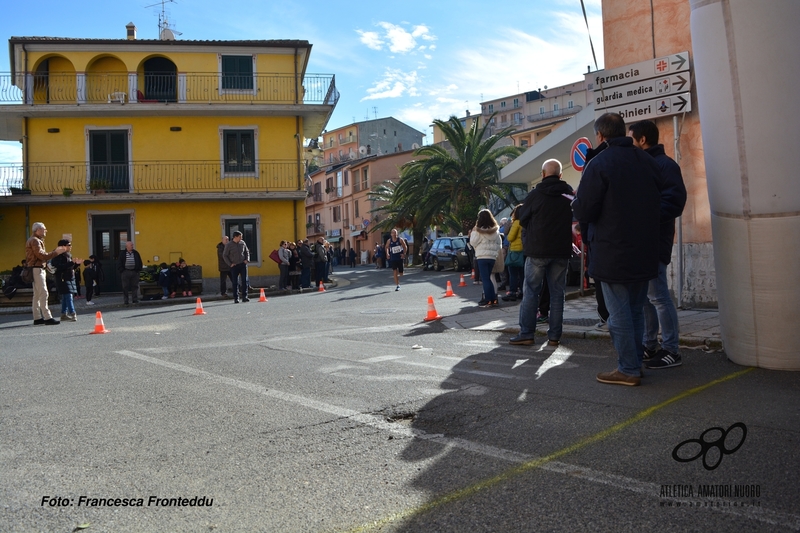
left=0, top=0, right=603, bottom=161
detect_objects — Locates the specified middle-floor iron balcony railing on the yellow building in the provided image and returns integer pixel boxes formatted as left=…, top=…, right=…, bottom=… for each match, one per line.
left=0, top=161, right=302, bottom=195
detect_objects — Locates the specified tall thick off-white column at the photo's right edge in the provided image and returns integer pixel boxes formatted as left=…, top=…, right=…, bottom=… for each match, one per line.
left=690, top=0, right=800, bottom=370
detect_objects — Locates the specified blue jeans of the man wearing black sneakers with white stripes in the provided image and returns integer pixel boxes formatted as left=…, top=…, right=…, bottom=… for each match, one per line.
left=642, top=262, right=679, bottom=353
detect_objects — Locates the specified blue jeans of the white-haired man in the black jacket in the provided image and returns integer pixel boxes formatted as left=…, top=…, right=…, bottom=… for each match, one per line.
left=519, top=257, right=569, bottom=341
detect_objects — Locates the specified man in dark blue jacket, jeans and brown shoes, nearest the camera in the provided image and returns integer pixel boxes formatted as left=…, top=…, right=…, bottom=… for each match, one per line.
left=572, top=113, right=680, bottom=386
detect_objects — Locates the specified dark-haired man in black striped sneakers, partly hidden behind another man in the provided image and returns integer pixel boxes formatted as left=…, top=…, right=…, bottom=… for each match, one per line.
left=628, top=120, right=686, bottom=368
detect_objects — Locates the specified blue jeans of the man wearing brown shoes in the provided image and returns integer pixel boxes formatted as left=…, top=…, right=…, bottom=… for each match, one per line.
left=600, top=281, right=648, bottom=377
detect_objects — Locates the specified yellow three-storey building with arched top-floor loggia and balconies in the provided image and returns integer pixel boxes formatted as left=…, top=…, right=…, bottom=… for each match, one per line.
left=0, top=24, right=339, bottom=291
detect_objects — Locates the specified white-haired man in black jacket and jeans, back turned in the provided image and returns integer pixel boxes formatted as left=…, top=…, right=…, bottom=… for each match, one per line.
left=509, top=159, right=574, bottom=346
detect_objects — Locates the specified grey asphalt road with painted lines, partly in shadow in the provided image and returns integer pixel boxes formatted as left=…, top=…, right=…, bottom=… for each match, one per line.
left=0, top=269, right=800, bottom=532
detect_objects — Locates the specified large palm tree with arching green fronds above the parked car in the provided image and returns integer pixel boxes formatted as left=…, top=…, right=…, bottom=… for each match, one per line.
left=412, top=115, right=524, bottom=232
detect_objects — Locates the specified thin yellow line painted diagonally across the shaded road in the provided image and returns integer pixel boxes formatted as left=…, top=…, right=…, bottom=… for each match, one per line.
left=348, top=367, right=755, bottom=533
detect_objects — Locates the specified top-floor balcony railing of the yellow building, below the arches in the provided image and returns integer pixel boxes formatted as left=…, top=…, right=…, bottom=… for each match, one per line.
left=0, top=72, right=339, bottom=105
